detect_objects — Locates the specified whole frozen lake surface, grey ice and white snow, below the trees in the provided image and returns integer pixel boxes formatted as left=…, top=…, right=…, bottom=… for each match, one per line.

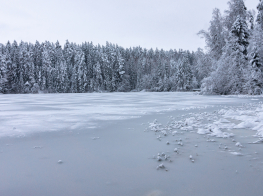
left=0, top=92, right=263, bottom=196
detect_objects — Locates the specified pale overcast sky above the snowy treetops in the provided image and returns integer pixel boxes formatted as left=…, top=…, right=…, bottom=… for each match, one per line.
left=0, top=0, right=259, bottom=50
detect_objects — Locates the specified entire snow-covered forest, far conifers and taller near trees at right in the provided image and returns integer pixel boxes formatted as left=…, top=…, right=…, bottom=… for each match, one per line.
left=0, top=0, right=263, bottom=95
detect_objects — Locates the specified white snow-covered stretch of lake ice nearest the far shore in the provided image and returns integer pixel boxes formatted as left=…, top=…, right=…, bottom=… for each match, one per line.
left=0, top=92, right=242, bottom=137
